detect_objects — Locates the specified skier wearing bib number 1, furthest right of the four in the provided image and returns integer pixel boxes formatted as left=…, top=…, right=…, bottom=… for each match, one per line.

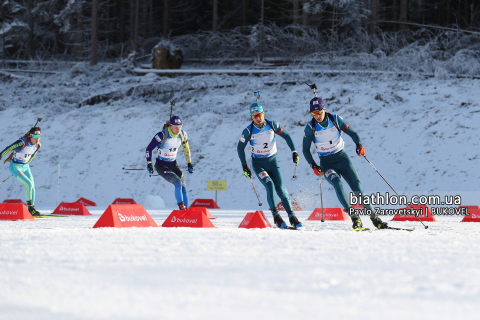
left=303, top=97, right=388, bottom=229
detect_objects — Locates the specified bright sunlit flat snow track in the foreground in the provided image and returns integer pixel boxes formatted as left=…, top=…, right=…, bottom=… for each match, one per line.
left=0, top=208, right=480, bottom=319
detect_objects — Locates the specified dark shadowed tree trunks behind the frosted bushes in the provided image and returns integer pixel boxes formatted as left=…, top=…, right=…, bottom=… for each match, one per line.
left=0, top=0, right=480, bottom=64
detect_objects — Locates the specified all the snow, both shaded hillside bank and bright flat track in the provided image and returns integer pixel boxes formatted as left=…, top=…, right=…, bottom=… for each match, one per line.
left=0, top=64, right=480, bottom=320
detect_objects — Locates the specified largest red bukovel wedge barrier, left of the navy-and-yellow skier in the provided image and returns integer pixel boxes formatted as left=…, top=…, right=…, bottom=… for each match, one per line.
left=93, top=204, right=158, bottom=228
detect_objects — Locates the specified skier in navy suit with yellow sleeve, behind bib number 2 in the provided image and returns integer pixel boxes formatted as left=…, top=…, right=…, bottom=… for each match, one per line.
left=145, top=116, right=194, bottom=210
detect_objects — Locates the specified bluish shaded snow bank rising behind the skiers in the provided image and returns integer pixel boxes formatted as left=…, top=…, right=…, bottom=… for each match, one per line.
left=0, top=64, right=480, bottom=210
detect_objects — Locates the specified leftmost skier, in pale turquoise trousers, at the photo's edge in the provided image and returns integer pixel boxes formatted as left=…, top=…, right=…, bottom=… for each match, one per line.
left=0, top=127, right=42, bottom=216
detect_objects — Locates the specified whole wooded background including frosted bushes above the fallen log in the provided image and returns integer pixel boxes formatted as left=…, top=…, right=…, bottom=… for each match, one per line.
left=0, top=0, right=480, bottom=75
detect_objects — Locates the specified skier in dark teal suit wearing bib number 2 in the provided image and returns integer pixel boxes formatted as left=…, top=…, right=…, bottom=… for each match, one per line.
left=237, top=103, right=302, bottom=229
